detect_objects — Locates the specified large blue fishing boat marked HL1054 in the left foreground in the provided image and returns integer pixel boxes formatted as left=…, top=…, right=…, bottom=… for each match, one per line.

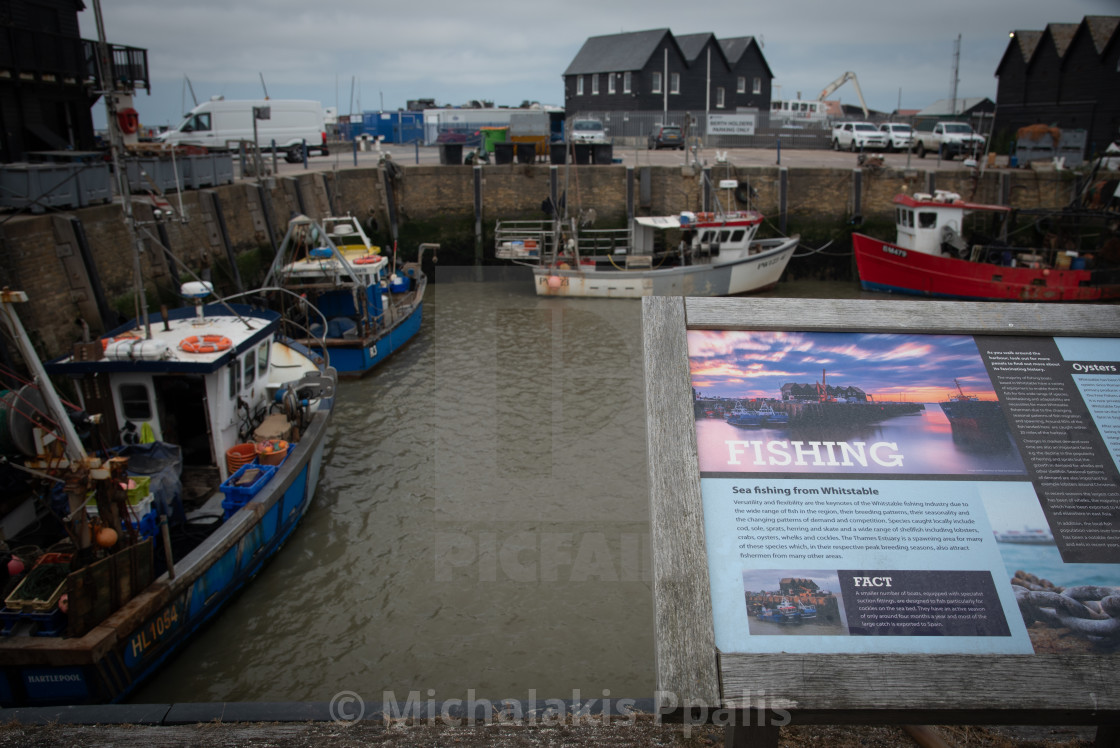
left=0, top=282, right=337, bottom=707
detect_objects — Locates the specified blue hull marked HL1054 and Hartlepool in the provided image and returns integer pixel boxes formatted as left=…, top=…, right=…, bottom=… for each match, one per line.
left=0, top=391, right=333, bottom=708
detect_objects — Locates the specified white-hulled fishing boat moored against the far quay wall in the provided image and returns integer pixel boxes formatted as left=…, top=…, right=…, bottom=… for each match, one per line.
left=494, top=180, right=800, bottom=299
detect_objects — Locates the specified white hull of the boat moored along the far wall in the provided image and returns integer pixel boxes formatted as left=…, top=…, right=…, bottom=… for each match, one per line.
left=533, top=236, right=799, bottom=299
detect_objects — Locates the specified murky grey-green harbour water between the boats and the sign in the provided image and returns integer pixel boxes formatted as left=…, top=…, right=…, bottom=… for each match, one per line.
left=132, top=268, right=654, bottom=703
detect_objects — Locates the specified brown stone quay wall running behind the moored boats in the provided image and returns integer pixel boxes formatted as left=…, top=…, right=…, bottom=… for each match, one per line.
left=0, top=163, right=1077, bottom=357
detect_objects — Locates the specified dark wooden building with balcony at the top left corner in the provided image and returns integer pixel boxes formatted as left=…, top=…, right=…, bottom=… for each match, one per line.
left=0, top=0, right=148, bottom=162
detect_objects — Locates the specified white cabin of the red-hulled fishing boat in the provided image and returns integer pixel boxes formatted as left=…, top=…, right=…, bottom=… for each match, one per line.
left=895, top=190, right=1010, bottom=255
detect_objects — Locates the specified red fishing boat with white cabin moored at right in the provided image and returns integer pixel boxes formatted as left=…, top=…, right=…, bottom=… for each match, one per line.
left=852, top=190, right=1120, bottom=301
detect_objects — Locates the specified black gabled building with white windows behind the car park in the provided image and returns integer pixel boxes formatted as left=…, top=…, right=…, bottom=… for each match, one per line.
left=563, top=29, right=774, bottom=112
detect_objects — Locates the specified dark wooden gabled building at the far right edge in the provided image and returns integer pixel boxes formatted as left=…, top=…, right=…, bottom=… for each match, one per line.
left=993, top=16, right=1120, bottom=156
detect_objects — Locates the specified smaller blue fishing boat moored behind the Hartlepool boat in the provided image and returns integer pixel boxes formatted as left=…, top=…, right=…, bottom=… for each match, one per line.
left=264, top=215, right=439, bottom=377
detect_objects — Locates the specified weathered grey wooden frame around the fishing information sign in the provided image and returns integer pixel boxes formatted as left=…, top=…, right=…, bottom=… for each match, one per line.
left=643, top=297, right=1120, bottom=745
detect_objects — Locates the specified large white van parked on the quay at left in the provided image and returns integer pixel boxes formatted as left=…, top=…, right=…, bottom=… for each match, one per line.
left=159, top=97, right=327, bottom=161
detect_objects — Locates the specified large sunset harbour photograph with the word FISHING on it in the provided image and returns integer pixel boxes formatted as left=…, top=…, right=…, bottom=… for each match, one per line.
left=688, top=330, right=1025, bottom=476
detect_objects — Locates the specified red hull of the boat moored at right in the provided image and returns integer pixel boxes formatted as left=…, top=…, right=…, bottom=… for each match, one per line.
left=852, top=234, right=1120, bottom=301
